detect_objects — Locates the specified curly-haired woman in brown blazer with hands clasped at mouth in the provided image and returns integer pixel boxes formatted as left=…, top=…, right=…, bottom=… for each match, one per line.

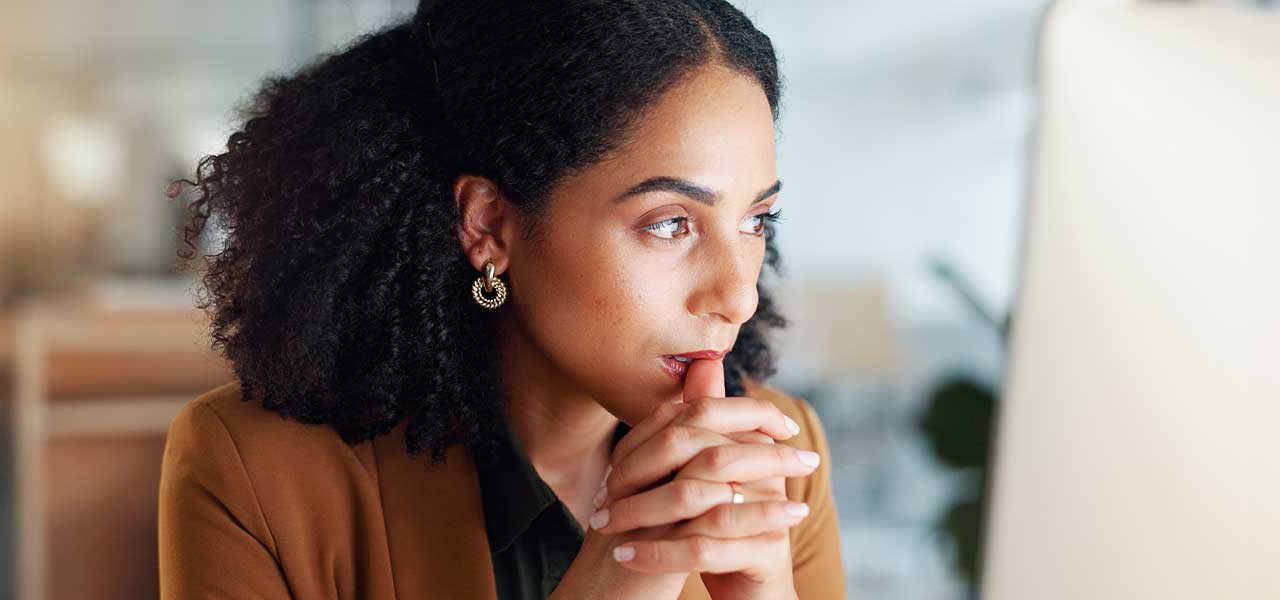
left=159, top=0, right=844, bottom=600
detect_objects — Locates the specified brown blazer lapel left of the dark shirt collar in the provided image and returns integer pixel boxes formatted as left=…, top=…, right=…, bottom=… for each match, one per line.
left=372, top=421, right=498, bottom=600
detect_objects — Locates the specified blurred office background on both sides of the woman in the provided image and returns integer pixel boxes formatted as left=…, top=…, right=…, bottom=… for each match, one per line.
left=0, top=0, right=1267, bottom=600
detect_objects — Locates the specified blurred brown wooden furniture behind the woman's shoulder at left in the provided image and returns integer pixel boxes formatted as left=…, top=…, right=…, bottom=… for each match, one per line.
left=10, top=286, right=233, bottom=600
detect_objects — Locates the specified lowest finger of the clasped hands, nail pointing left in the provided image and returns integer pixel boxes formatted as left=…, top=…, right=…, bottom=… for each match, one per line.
left=613, top=530, right=788, bottom=573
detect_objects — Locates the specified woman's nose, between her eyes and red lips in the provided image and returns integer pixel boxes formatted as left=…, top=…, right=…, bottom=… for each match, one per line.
left=689, top=241, right=764, bottom=325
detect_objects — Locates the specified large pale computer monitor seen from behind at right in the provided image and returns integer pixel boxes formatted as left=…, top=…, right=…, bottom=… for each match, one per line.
left=980, top=1, right=1280, bottom=600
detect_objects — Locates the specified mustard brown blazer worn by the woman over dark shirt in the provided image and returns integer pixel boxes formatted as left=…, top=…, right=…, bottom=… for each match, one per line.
left=159, top=380, right=845, bottom=600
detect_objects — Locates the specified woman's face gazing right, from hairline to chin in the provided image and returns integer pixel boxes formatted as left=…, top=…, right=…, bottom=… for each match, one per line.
left=471, top=65, right=778, bottom=425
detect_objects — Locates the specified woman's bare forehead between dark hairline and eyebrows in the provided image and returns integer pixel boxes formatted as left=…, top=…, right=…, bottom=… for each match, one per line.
left=545, top=65, right=776, bottom=197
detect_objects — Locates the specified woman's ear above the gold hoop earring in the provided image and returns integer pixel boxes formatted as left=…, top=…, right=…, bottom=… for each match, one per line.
left=453, top=175, right=517, bottom=274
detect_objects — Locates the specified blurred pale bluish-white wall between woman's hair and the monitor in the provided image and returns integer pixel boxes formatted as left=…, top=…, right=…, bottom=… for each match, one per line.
left=735, top=0, right=1044, bottom=324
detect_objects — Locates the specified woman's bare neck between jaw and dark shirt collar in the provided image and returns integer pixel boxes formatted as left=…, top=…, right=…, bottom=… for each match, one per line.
left=499, top=310, right=618, bottom=493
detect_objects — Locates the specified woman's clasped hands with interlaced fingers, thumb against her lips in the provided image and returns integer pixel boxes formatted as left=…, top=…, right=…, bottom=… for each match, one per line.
left=590, top=361, right=819, bottom=600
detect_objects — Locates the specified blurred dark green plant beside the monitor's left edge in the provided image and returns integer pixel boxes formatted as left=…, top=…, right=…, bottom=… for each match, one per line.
left=916, top=258, right=1012, bottom=595
